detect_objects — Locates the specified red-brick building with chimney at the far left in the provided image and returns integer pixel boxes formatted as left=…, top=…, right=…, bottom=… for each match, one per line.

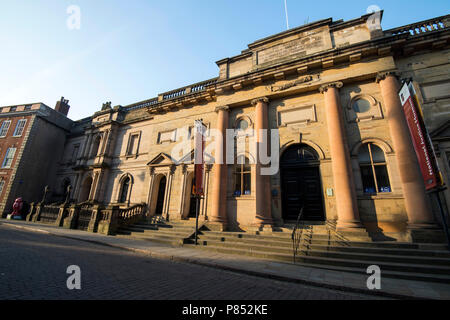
left=0, top=98, right=72, bottom=217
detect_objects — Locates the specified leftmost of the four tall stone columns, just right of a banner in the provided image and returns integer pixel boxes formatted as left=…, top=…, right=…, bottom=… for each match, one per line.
left=210, top=106, right=230, bottom=229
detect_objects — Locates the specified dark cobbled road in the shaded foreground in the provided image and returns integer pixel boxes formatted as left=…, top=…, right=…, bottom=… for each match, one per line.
left=0, top=225, right=367, bottom=300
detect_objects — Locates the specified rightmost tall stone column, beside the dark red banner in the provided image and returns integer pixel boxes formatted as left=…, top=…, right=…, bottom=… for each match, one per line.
left=377, top=72, right=435, bottom=229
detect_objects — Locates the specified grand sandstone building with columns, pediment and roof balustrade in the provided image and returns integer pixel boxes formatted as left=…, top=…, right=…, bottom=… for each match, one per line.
left=52, top=15, right=450, bottom=239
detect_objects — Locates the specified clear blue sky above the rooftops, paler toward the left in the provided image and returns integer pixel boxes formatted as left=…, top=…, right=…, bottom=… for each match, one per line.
left=0, top=0, right=450, bottom=120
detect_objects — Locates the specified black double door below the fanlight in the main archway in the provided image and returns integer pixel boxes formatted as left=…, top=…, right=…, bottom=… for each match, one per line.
left=281, top=166, right=325, bottom=221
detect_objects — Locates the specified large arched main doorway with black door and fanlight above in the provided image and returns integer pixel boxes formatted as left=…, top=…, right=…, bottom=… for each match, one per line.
left=280, top=144, right=325, bottom=221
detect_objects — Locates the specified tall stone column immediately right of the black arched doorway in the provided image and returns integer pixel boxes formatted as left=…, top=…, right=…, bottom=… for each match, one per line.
left=320, top=82, right=362, bottom=231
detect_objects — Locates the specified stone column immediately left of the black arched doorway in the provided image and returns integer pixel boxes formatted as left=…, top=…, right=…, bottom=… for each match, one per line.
left=252, top=97, right=273, bottom=227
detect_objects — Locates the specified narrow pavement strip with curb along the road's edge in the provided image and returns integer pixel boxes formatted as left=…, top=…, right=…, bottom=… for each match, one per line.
left=0, top=222, right=435, bottom=300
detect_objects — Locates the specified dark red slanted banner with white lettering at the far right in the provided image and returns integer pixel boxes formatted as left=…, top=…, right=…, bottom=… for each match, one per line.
left=399, top=83, right=442, bottom=190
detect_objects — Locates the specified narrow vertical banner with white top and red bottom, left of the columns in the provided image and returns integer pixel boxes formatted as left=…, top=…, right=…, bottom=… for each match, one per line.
left=194, top=120, right=205, bottom=196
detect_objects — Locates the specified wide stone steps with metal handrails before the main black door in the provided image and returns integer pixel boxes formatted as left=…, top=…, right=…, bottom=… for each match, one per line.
left=185, top=225, right=450, bottom=283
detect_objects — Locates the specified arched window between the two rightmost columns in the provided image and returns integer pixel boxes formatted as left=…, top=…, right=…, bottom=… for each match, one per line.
left=358, top=143, right=391, bottom=193
